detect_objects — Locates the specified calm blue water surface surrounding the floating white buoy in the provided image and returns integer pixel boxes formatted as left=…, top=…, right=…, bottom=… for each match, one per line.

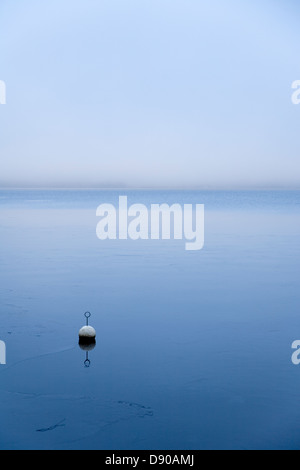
left=0, top=190, right=300, bottom=450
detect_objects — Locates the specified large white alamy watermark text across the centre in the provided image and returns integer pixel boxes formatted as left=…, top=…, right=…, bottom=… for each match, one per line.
left=96, top=196, right=204, bottom=251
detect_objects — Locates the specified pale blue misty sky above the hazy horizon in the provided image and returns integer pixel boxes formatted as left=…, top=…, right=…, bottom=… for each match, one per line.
left=0, top=0, right=300, bottom=188
